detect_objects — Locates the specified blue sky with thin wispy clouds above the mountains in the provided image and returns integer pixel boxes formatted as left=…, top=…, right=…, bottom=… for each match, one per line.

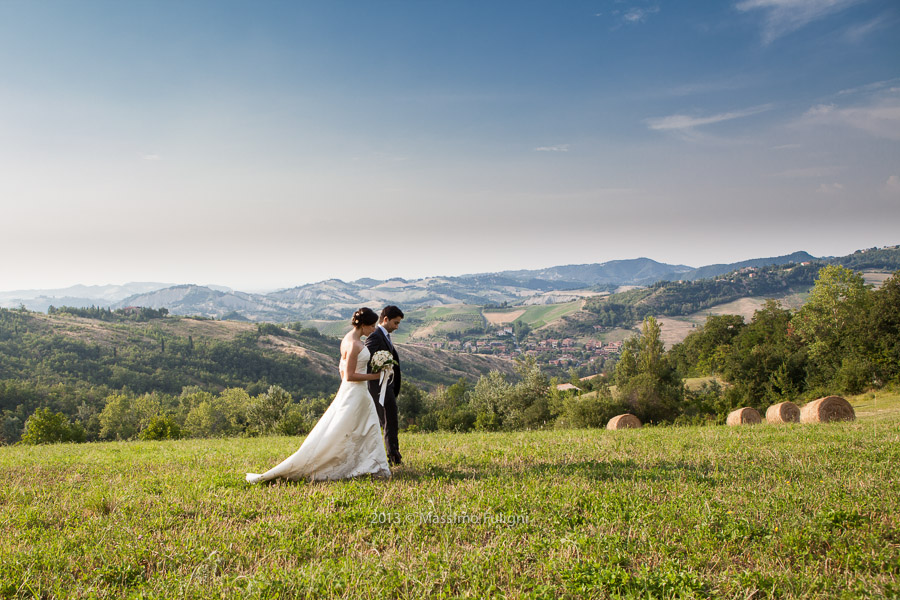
left=0, top=0, right=900, bottom=290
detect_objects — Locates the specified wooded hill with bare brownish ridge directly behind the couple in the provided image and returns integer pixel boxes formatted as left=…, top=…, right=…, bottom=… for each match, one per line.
left=0, top=309, right=512, bottom=410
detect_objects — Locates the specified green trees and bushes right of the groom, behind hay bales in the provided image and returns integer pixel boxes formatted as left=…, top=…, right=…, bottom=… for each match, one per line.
left=392, top=265, right=900, bottom=431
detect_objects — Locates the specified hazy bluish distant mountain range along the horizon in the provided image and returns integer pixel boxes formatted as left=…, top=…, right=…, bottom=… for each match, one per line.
left=0, top=249, right=900, bottom=322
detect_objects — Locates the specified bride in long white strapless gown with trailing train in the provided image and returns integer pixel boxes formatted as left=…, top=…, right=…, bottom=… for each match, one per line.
left=247, top=308, right=391, bottom=483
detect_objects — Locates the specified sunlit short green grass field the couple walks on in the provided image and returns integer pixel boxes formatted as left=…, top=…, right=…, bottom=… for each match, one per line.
left=0, top=394, right=900, bottom=599
